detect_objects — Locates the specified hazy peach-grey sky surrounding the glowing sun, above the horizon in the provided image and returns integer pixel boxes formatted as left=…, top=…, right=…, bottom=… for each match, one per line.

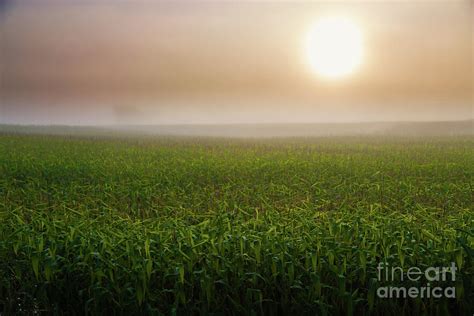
left=0, top=0, right=474, bottom=124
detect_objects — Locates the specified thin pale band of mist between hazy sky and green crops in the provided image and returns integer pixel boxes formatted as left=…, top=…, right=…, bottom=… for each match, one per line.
left=0, top=120, right=474, bottom=138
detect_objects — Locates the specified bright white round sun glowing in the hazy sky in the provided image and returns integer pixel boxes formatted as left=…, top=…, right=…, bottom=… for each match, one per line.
left=306, top=17, right=364, bottom=79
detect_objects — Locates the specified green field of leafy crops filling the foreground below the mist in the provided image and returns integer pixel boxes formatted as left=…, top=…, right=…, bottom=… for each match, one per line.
left=0, top=134, right=474, bottom=315
